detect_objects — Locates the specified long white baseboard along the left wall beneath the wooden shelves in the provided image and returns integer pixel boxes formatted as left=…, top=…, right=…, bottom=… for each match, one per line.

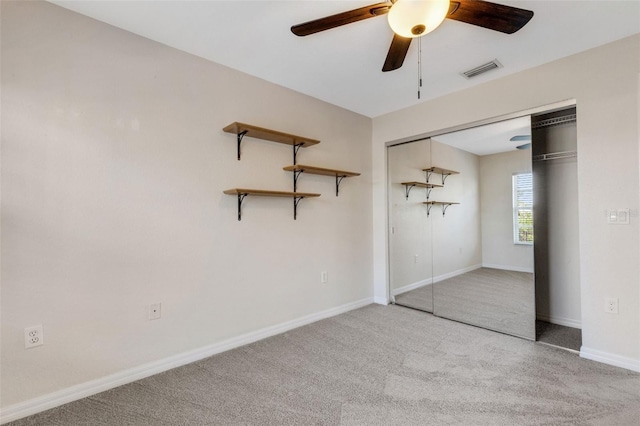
left=0, top=297, right=374, bottom=424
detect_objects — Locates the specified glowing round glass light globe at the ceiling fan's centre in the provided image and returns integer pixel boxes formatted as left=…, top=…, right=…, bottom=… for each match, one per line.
left=387, top=0, right=449, bottom=38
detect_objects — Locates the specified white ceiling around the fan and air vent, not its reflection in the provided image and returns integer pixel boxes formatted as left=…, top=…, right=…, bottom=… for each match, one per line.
left=50, top=0, right=640, bottom=117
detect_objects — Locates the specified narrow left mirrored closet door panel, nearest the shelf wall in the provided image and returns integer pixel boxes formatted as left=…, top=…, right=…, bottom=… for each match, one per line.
left=387, top=140, right=433, bottom=312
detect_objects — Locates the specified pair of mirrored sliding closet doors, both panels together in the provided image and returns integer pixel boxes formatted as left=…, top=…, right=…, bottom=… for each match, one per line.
left=388, top=116, right=535, bottom=339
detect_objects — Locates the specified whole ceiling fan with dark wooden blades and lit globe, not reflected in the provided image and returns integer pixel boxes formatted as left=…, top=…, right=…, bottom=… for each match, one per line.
left=291, top=0, right=533, bottom=72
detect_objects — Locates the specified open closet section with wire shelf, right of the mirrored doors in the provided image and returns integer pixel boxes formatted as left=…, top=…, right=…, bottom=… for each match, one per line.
left=531, top=106, right=582, bottom=353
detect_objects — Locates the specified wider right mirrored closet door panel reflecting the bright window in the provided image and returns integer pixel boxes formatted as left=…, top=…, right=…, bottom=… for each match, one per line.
left=430, top=116, right=535, bottom=339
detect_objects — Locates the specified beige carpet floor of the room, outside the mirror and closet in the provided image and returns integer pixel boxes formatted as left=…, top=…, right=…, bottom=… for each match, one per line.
left=6, top=305, right=640, bottom=426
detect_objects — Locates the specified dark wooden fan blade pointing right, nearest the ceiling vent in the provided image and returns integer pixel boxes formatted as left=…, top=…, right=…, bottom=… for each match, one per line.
left=447, top=0, right=533, bottom=34
